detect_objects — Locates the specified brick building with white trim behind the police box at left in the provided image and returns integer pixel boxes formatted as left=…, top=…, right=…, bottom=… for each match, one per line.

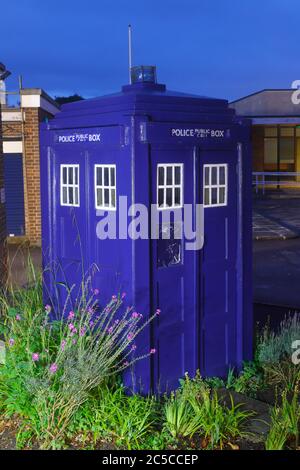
left=1, top=88, right=59, bottom=245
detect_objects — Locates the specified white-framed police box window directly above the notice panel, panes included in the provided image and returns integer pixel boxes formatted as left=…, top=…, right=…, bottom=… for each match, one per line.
left=157, top=163, right=183, bottom=210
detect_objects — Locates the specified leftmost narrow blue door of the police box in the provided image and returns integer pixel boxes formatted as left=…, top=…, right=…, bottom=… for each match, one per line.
left=54, top=145, right=89, bottom=308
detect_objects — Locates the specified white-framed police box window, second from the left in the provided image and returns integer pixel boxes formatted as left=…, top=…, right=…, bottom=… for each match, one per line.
left=95, top=165, right=117, bottom=211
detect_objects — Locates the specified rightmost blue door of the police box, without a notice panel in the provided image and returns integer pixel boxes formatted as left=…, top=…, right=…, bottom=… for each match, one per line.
left=199, top=150, right=238, bottom=376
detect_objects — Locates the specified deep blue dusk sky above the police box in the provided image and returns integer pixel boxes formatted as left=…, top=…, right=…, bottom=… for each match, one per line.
left=0, top=0, right=300, bottom=100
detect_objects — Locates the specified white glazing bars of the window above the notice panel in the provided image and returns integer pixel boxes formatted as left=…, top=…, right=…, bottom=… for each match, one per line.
left=156, top=163, right=184, bottom=211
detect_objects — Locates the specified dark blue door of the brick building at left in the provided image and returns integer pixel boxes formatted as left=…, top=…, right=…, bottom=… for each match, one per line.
left=4, top=154, right=25, bottom=236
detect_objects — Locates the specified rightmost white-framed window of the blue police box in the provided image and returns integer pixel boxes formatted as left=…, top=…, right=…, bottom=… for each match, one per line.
left=203, top=163, right=228, bottom=207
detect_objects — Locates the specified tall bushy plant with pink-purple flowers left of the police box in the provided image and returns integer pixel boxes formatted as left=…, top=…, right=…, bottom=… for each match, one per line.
left=0, top=274, right=156, bottom=448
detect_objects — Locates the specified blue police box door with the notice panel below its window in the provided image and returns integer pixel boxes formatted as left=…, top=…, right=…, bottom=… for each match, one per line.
left=151, top=145, right=197, bottom=392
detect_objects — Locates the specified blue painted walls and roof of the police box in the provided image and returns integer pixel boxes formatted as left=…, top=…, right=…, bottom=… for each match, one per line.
left=41, top=73, right=253, bottom=393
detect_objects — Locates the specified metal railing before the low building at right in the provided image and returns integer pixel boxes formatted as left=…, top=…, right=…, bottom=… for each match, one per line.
left=252, top=171, right=300, bottom=194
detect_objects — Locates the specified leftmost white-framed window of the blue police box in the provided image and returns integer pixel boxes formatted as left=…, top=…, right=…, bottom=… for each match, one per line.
left=60, top=165, right=80, bottom=207
